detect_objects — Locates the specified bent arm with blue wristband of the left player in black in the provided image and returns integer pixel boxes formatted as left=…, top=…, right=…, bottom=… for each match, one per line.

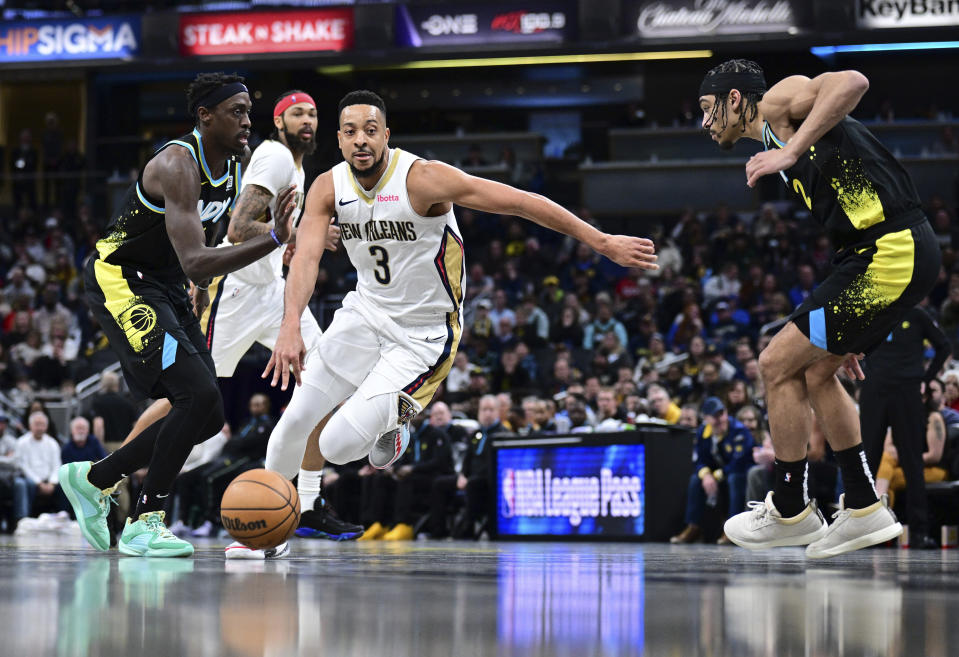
left=159, top=148, right=294, bottom=281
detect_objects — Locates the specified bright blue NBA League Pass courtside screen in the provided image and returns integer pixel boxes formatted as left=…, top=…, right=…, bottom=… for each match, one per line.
left=496, top=445, right=646, bottom=537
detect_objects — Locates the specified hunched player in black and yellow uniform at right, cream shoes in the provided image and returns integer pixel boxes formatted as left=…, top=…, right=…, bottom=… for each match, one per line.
left=699, top=60, right=941, bottom=558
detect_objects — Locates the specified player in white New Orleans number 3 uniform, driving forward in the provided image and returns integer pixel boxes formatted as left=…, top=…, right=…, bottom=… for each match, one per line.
left=263, top=91, right=656, bottom=486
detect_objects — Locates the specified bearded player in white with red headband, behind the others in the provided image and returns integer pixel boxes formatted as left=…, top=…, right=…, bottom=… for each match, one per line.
left=120, top=90, right=363, bottom=559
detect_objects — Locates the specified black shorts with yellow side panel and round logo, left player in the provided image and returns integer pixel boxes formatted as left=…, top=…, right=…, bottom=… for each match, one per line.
left=83, top=256, right=216, bottom=399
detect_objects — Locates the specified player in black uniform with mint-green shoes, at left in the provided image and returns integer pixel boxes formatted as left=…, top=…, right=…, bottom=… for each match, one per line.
left=60, top=73, right=294, bottom=557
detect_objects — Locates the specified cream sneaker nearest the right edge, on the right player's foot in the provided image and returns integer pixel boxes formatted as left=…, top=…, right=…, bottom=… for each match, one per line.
left=806, top=495, right=902, bottom=559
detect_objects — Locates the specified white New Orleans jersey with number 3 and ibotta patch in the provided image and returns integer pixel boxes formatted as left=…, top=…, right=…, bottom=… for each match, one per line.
left=330, top=148, right=466, bottom=326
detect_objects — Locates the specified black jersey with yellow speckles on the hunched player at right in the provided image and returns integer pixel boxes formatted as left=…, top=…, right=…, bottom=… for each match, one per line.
left=763, top=116, right=924, bottom=249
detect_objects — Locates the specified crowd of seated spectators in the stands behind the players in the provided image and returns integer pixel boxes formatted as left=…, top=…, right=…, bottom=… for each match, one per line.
left=0, top=116, right=959, bottom=534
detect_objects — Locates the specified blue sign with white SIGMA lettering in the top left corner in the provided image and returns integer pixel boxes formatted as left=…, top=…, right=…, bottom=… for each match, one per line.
left=0, top=16, right=141, bottom=62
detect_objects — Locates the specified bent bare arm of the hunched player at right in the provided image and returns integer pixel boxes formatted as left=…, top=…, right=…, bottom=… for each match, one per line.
left=746, top=71, right=869, bottom=187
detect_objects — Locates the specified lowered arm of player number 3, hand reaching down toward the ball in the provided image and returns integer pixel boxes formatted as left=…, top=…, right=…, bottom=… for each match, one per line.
left=262, top=171, right=334, bottom=390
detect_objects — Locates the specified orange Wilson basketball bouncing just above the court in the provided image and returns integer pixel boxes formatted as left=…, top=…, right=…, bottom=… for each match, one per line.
left=220, top=469, right=300, bottom=550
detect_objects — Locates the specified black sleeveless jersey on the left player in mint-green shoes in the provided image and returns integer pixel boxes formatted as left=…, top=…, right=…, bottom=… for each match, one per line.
left=97, top=129, right=242, bottom=282
